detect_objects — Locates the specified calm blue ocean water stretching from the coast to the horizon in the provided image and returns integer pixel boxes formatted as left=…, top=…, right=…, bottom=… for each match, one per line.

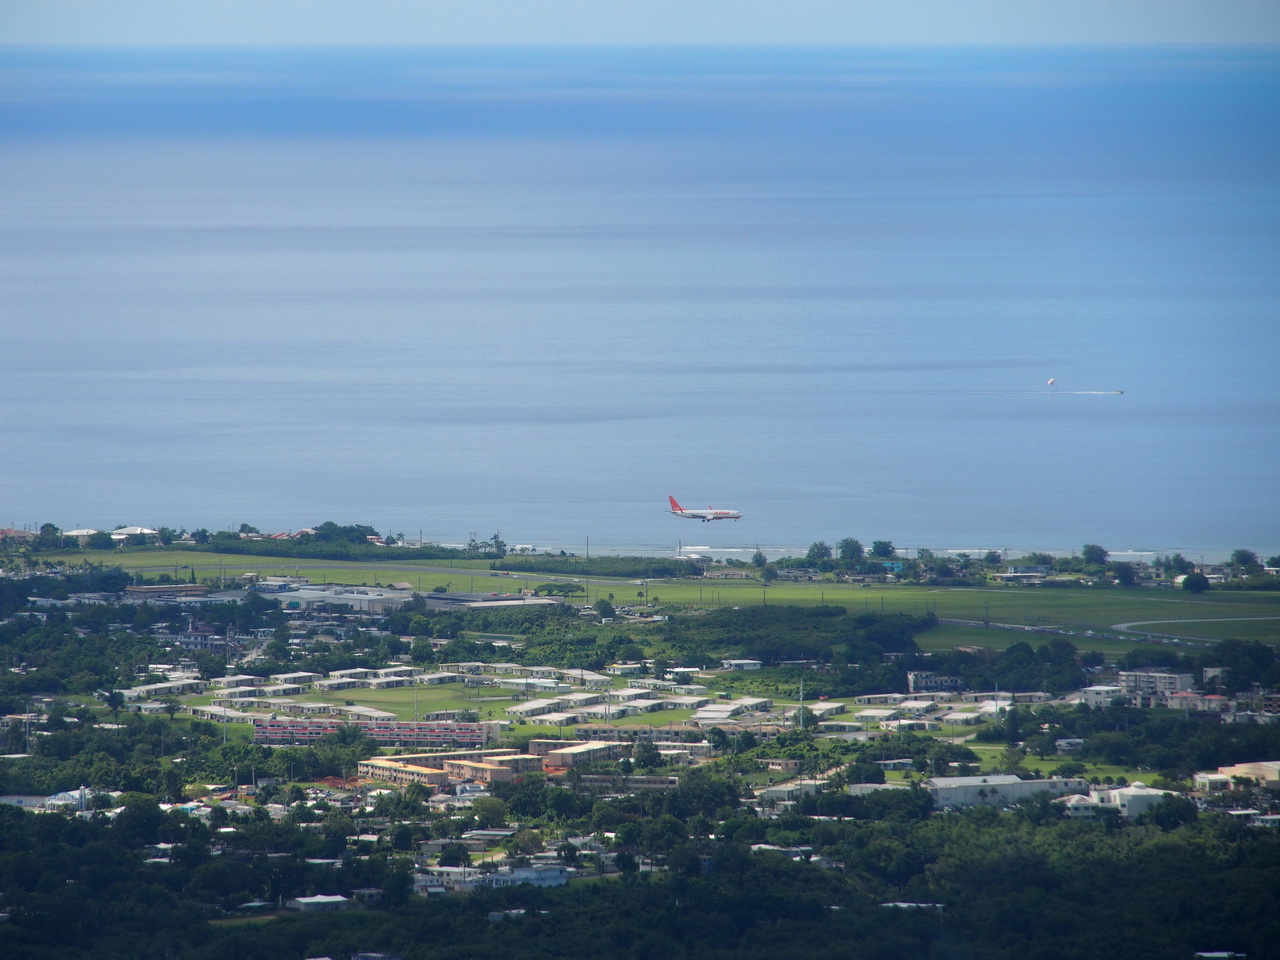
left=0, top=49, right=1280, bottom=557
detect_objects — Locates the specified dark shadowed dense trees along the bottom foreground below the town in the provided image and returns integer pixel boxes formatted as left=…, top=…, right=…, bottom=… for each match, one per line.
left=0, top=791, right=1280, bottom=960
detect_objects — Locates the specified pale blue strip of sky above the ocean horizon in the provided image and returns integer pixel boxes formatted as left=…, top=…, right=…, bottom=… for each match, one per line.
left=0, top=0, right=1280, bottom=45
